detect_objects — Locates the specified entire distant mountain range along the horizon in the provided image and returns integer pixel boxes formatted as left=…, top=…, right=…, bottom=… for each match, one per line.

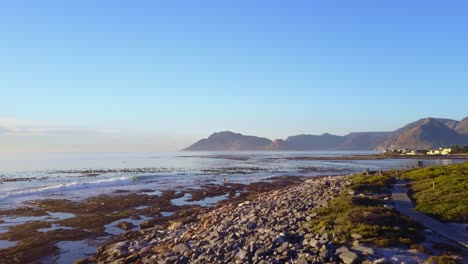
left=183, top=117, right=468, bottom=151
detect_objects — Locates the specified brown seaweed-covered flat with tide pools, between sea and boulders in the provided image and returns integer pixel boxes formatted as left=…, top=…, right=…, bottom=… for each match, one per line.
left=0, top=176, right=304, bottom=263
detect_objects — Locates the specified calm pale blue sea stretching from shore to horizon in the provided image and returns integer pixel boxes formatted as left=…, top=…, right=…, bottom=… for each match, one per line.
left=0, top=151, right=460, bottom=208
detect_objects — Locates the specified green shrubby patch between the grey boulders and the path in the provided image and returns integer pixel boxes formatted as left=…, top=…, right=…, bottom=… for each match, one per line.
left=309, top=174, right=423, bottom=247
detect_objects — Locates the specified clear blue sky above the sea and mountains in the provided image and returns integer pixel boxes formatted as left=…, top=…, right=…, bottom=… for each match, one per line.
left=0, top=0, right=468, bottom=152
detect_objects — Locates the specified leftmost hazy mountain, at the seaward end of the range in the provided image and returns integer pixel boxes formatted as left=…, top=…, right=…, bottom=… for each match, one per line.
left=183, top=131, right=273, bottom=151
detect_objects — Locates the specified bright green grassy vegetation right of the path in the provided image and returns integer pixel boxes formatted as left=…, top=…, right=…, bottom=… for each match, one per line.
left=401, top=162, right=468, bottom=222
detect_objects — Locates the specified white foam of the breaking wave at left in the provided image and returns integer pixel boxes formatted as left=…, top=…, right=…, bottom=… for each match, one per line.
left=0, top=176, right=134, bottom=200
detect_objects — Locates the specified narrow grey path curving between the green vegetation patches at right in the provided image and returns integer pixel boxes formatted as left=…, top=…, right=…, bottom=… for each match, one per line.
left=392, top=180, right=468, bottom=248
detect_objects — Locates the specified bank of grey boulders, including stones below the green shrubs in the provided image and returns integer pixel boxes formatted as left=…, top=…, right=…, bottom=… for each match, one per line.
left=82, top=173, right=466, bottom=264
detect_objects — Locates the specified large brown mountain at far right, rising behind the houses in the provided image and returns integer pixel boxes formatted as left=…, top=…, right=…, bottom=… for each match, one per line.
left=377, top=118, right=468, bottom=149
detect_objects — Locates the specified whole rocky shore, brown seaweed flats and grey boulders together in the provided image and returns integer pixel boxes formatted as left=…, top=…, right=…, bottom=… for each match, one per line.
left=0, top=167, right=464, bottom=264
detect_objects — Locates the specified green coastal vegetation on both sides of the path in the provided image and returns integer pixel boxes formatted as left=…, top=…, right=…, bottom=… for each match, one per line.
left=309, top=162, right=468, bottom=250
